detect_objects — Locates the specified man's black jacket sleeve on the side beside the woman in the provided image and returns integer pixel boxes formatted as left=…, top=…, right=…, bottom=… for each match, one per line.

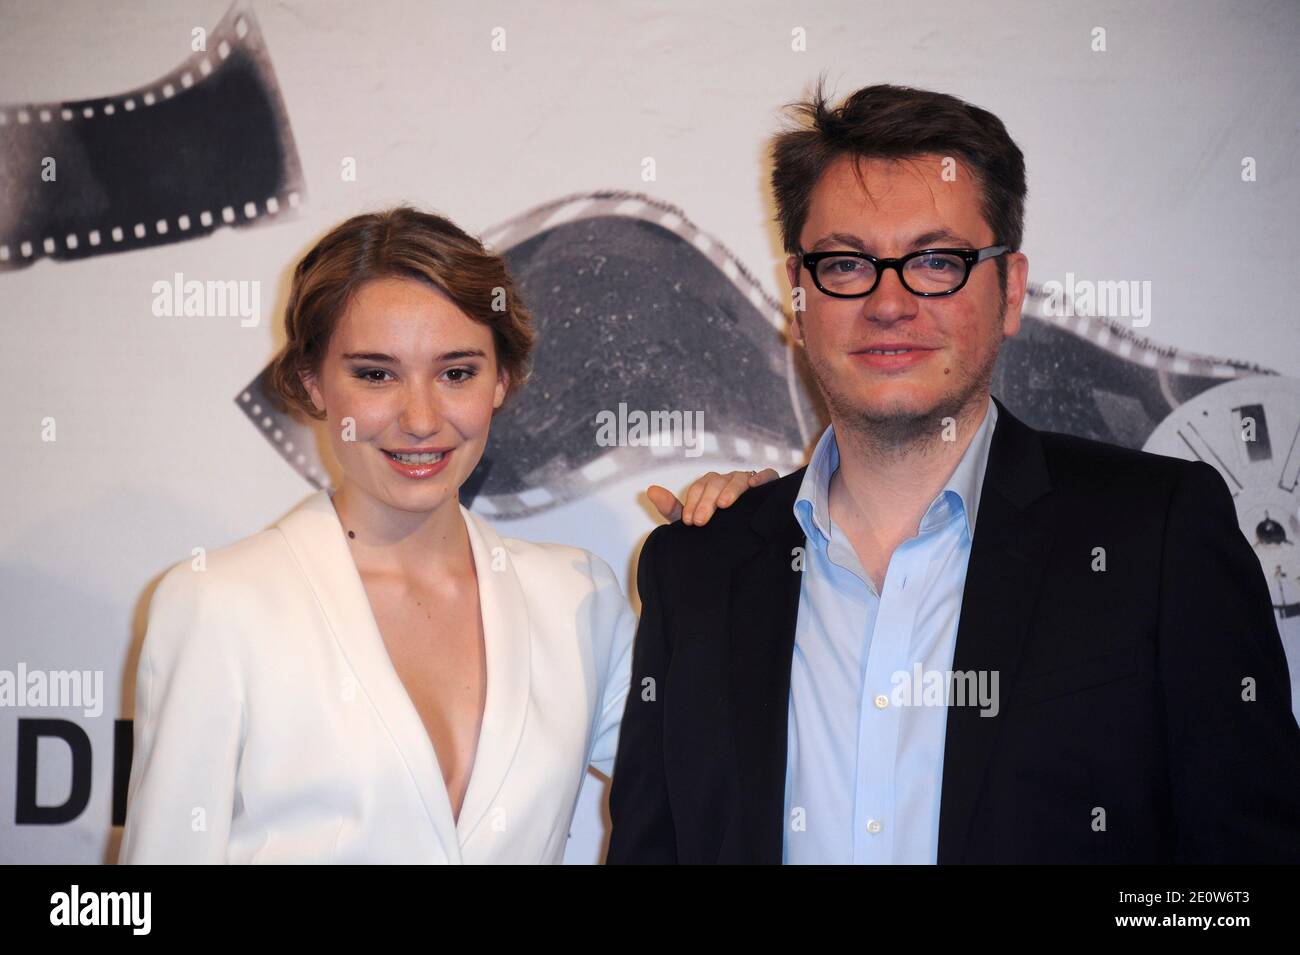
left=606, top=526, right=677, bottom=864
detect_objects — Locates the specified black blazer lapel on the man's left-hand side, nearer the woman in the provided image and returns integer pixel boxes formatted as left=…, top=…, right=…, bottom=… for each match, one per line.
left=727, top=468, right=805, bottom=864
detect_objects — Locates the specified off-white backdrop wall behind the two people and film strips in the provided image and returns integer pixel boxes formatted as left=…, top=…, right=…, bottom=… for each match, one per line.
left=0, top=0, right=1300, bottom=861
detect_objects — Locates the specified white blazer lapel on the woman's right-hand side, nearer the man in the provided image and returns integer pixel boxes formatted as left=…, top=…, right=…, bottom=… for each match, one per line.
left=458, top=507, right=532, bottom=842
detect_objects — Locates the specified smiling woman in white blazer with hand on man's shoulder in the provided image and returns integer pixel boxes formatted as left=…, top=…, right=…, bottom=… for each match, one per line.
left=121, top=208, right=775, bottom=863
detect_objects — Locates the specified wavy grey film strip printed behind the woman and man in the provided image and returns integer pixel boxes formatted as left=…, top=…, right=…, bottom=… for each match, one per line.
left=235, top=191, right=1273, bottom=520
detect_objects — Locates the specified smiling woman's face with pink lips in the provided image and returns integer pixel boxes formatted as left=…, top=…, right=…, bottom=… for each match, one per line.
left=303, top=278, right=507, bottom=512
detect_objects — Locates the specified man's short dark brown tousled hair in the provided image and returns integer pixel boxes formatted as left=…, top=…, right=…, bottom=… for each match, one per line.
left=772, top=79, right=1027, bottom=294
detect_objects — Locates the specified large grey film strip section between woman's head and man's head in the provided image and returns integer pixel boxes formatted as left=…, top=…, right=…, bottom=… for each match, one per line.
left=462, top=191, right=822, bottom=518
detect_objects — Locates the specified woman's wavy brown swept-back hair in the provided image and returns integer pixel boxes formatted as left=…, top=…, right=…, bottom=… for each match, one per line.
left=268, top=205, right=534, bottom=420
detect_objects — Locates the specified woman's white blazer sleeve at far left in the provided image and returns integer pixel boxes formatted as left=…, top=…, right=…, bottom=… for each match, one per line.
left=121, top=564, right=243, bottom=863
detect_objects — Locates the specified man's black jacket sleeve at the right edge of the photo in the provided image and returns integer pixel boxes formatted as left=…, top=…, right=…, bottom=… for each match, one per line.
left=1158, top=461, right=1300, bottom=863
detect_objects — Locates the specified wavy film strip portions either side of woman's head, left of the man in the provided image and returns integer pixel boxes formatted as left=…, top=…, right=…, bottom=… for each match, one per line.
left=235, top=192, right=820, bottom=518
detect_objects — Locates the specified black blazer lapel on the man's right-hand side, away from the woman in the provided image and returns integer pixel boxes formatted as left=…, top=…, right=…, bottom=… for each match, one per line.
left=939, top=399, right=1050, bottom=864
